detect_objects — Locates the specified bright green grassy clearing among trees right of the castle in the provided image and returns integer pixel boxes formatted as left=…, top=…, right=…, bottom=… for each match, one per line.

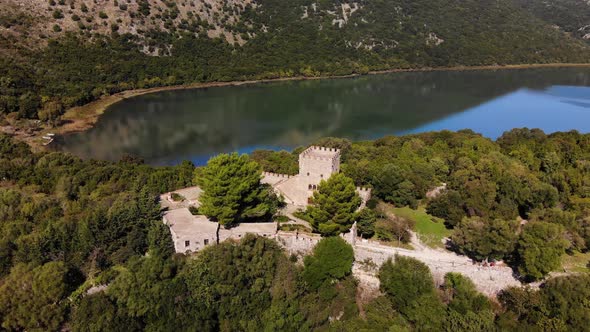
left=391, top=207, right=451, bottom=248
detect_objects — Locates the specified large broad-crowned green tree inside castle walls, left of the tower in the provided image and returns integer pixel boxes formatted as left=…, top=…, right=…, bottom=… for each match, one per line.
left=198, top=153, right=277, bottom=227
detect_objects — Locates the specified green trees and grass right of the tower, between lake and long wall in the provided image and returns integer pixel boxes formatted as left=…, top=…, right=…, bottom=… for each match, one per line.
left=256, top=128, right=590, bottom=279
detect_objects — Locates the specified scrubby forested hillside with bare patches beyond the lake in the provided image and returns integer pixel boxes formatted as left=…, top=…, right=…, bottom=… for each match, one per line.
left=0, top=0, right=590, bottom=123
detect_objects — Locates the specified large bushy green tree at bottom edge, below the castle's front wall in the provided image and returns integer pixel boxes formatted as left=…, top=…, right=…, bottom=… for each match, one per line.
left=182, top=234, right=287, bottom=331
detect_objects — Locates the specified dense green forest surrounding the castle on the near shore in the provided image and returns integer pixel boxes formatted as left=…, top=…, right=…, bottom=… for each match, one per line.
left=0, top=129, right=590, bottom=331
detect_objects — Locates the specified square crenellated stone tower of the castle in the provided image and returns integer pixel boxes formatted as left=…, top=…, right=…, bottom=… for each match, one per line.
left=299, top=146, right=340, bottom=190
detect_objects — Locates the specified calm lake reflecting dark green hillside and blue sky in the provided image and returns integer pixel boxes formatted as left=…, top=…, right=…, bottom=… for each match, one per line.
left=55, top=68, right=590, bottom=165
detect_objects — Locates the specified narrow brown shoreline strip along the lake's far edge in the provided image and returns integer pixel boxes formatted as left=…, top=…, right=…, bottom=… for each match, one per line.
left=15, top=63, right=590, bottom=150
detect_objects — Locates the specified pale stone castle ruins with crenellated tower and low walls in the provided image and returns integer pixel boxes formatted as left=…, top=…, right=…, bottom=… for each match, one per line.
left=160, top=146, right=371, bottom=253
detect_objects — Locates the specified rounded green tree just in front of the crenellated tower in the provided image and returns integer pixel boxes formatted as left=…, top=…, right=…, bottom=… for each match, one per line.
left=307, top=173, right=361, bottom=236
